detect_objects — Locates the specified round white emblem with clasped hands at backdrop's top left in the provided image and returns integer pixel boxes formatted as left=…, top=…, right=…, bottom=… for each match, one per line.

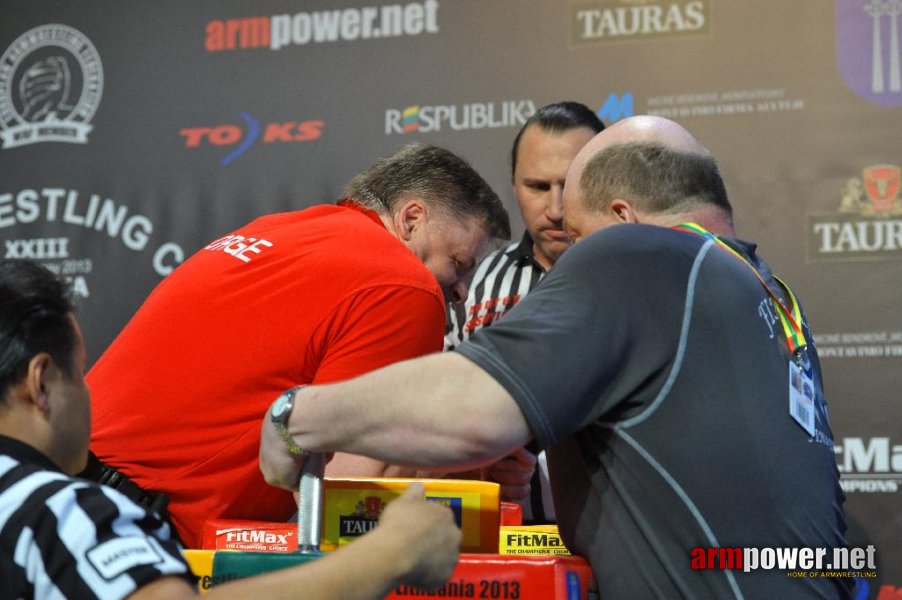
left=0, top=23, right=103, bottom=148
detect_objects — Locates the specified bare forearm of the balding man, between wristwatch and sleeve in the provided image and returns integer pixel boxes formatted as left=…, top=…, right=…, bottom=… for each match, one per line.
left=289, top=353, right=530, bottom=468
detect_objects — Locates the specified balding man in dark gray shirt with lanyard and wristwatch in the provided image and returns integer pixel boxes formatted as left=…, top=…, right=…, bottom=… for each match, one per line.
left=261, top=116, right=851, bottom=598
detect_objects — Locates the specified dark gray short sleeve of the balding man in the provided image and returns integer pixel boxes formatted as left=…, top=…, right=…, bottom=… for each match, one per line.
left=456, top=226, right=681, bottom=448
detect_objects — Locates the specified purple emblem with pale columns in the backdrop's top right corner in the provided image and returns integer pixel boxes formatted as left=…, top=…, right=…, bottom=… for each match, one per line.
left=836, top=0, right=902, bottom=106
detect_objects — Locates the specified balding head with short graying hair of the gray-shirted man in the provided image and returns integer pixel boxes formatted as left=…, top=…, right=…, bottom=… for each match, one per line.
left=564, top=115, right=733, bottom=237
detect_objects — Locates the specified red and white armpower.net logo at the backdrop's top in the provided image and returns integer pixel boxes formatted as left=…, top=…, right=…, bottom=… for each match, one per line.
left=204, top=0, right=438, bottom=52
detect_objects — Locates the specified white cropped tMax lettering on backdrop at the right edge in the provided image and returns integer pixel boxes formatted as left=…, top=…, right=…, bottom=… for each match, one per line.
left=833, top=437, right=902, bottom=492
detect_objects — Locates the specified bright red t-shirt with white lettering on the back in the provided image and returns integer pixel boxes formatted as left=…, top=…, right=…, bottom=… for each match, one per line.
left=87, top=206, right=445, bottom=547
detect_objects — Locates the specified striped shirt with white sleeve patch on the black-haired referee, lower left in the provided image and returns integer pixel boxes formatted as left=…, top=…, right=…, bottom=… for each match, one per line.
left=0, top=436, right=194, bottom=600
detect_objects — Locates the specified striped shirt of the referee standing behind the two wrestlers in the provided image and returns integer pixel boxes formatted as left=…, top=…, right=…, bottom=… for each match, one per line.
left=445, top=232, right=555, bottom=523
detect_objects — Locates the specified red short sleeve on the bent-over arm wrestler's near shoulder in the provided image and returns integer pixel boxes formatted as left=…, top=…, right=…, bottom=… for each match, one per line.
left=311, top=285, right=445, bottom=384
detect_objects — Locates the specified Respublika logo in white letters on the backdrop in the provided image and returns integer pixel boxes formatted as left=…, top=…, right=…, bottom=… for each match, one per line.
left=385, top=100, right=536, bottom=135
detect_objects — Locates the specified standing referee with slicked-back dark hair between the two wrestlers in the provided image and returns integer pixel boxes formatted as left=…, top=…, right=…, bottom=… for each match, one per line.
left=445, top=102, right=604, bottom=523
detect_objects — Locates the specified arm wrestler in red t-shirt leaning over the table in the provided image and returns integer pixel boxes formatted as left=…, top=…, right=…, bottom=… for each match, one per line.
left=87, top=145, right=534, bottom=547
